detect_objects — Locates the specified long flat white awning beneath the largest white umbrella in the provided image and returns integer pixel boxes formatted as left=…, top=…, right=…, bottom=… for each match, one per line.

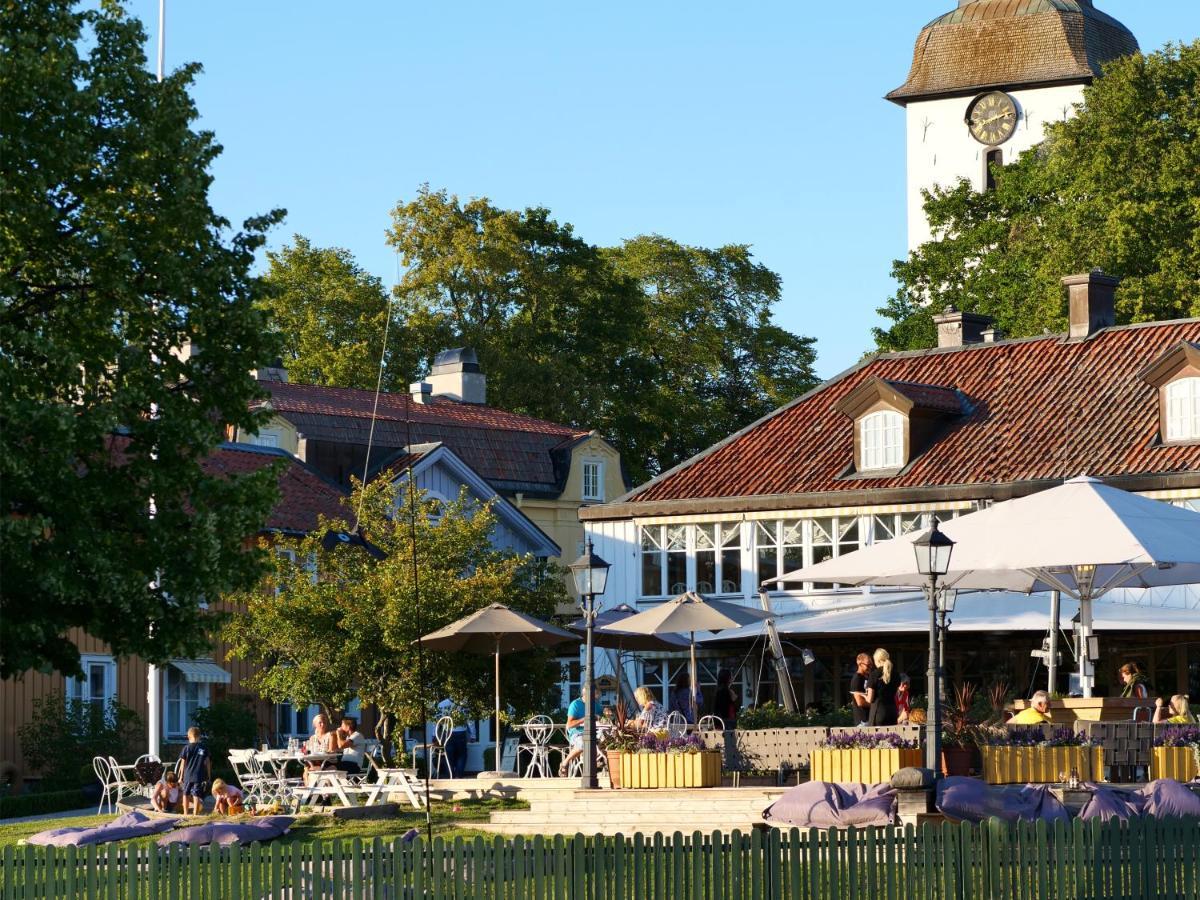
left=700, top=590, right=1200, bottom=643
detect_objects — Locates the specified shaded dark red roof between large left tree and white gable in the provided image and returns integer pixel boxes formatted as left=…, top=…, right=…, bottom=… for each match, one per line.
left=204, top=444, right=347, bottom=533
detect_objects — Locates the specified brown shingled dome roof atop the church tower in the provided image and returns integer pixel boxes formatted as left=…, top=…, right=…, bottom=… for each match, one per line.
left=888, top=0, right=1138, bottom=106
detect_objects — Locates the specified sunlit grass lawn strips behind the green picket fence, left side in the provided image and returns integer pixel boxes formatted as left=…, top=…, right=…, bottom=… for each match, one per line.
left=0, top=799, right=529, bottom=847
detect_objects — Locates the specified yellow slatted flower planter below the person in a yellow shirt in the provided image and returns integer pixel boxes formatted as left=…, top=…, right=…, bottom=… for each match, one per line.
left=979, top=726, right=1104, bottom=785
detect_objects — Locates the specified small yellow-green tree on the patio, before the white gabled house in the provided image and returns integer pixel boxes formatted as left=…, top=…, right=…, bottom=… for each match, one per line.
left=223, top=479, right=568, bottom=740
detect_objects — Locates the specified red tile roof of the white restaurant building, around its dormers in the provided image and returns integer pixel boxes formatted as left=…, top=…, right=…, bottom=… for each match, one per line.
left=614, top=319, right=1200, bottom=508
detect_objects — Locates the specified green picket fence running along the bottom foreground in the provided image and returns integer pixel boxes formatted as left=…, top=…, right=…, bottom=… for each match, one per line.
left=0, top=820, right=1200, bottom=900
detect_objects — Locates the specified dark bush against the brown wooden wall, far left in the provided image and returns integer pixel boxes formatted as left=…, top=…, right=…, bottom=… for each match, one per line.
left=17, top=694, right=144, bottom=787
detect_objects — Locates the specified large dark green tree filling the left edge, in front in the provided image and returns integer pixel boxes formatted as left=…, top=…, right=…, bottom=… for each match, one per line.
left=0, top=0, right=282, bottom=677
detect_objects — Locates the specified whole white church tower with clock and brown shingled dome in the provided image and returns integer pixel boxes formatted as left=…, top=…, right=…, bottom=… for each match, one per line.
left=887, top=0, right=1138, bottom=251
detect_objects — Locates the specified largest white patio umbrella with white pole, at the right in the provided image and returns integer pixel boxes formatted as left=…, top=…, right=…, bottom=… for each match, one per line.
left=772, top=475, right=1200, bottom=696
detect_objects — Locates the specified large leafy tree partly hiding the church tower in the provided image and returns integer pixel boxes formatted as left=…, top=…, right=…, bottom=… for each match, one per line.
left=875, top=41, right=1200, bottom=349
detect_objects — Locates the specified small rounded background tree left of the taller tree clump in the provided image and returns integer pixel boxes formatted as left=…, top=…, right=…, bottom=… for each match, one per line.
left=263, top=234, right=400, bottom=390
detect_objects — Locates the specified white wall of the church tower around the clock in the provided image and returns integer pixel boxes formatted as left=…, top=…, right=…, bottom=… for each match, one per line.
left=905, top=84, right=1084, bottom=252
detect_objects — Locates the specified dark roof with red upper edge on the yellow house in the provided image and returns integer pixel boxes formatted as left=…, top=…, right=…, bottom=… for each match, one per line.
left=259, top=380, right=589, bottom=494
